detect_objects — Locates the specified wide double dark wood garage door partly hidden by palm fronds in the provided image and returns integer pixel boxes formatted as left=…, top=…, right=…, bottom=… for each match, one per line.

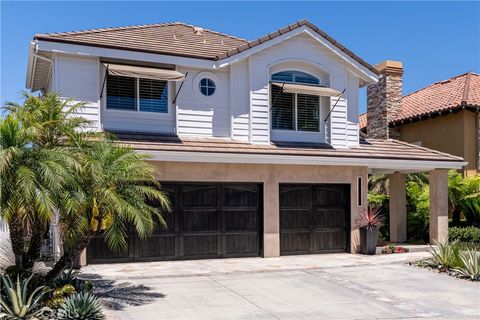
left=87, top=183, right=263, bottom=263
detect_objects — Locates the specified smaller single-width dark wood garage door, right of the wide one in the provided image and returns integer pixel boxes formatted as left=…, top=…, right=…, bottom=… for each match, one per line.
left=280, top=184, right=350, bottom=255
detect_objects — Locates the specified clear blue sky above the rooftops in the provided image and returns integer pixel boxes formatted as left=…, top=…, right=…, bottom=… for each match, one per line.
left=0, top=1, right=480, bottom=111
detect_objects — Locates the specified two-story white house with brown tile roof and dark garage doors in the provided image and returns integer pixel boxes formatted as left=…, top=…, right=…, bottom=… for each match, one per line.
left=27, top=20, right=465, bottom=263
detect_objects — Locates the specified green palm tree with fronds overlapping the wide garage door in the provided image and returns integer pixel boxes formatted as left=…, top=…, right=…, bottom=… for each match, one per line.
left=47, top=138, right=170, bottom=279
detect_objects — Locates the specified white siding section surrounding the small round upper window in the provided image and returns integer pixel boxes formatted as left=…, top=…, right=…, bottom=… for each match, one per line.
left=176, top=68, right=231, bottom=137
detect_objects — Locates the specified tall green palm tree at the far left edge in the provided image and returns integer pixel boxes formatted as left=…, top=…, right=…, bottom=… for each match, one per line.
left=0, top=93, right=89, bottom=268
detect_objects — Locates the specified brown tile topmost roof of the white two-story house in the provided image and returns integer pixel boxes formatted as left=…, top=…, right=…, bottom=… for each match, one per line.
left=34, top=19, right=378, bottom=74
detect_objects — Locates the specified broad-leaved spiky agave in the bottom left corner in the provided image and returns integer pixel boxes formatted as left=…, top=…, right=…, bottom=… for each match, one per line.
left=0, top=275, right=51, bottom=320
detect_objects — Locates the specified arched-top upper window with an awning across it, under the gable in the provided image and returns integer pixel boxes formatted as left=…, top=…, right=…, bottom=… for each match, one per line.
left=271, top=71, right=320, bottom=132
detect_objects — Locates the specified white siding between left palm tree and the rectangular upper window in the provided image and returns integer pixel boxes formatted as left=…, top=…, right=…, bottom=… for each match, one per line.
left=52, top=56, right=100, bottom=129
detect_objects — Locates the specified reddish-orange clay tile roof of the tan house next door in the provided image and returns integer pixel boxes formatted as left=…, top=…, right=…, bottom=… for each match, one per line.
left=359, top=72, right=480, bottom=128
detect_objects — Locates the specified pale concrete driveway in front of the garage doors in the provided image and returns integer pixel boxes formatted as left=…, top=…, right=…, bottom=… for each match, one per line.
left=83, top=252, right=480, bottom=319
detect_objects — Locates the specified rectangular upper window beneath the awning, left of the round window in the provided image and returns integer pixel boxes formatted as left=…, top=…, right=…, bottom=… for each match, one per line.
left=107, top=75, right=168, bottom=113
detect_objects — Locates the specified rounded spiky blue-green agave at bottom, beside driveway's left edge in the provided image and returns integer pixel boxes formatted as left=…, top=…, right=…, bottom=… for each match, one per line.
left=57, top=292, right=103, bottom=320
